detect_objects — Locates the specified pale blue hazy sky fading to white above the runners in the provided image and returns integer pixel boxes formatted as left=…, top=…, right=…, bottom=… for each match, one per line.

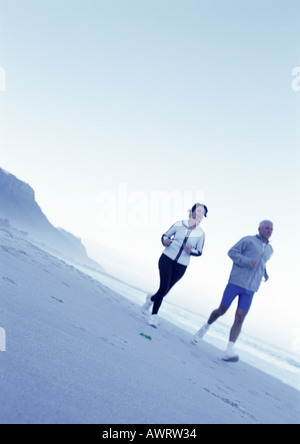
left=0, top=0, right=300, bottom=351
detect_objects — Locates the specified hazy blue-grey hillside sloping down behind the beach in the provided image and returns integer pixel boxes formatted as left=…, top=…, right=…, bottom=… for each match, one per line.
left=0, top=168, right=103, bottom=271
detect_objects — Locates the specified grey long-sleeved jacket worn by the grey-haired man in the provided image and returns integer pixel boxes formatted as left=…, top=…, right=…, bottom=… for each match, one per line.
left=228, top=234, right=273, bottom=292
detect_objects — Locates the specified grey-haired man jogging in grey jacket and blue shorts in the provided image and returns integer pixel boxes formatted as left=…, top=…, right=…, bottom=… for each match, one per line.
left=192, top=220, right=273, bottom=362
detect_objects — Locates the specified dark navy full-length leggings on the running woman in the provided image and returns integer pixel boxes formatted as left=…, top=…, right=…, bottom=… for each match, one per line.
left=151, top=254, right=187, bottom=314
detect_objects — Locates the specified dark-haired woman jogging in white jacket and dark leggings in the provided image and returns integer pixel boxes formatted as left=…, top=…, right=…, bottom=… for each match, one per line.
left=142, top=203, right=208, bottom=328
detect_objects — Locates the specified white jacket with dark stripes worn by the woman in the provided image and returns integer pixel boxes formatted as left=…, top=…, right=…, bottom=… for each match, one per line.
left=162, top=220, right=205, bottom=267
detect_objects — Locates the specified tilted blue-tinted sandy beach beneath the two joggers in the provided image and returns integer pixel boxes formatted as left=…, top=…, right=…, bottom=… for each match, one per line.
left=0, top=229, right=300, bottom=424
